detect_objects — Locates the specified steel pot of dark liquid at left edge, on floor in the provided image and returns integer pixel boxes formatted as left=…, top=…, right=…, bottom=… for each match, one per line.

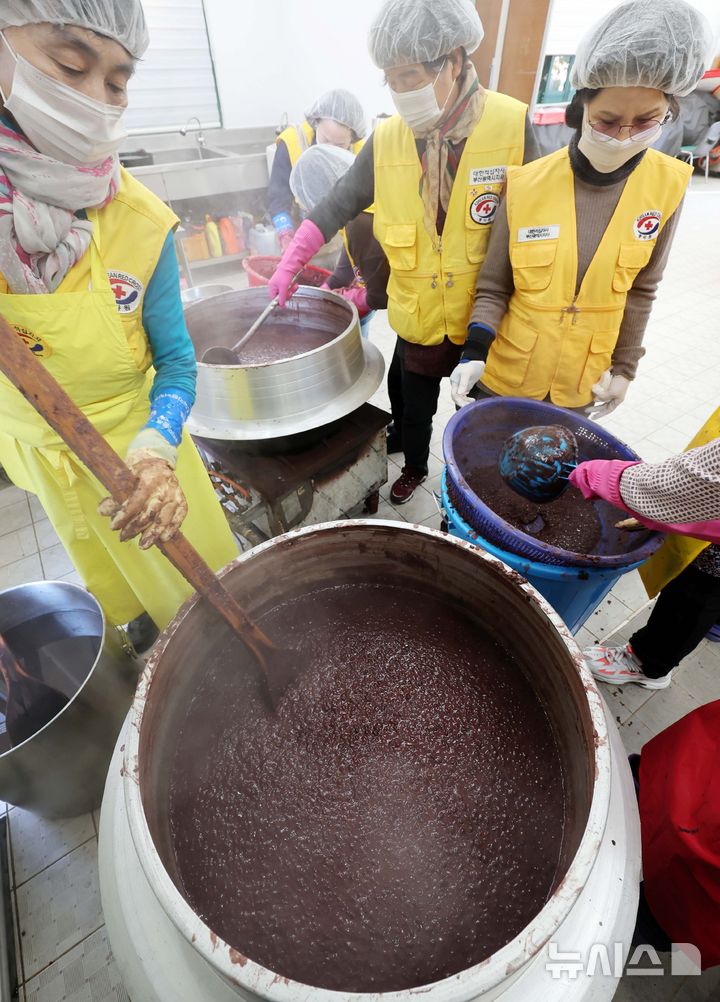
left=0, top=581, right=144, bottom=818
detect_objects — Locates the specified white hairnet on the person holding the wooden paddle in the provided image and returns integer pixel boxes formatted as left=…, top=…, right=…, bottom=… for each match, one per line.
left=0, top=0, right=150, bottom=59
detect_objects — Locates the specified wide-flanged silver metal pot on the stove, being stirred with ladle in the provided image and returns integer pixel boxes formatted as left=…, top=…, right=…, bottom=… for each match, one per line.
left=185, top=286, right=385, bottom=441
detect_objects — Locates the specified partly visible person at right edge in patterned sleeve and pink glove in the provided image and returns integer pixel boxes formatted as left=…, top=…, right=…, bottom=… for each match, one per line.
left=570, top=409, right=720, bottom=691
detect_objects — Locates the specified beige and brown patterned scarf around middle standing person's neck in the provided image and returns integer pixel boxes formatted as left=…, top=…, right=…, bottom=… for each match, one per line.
left=414, top=60, right=487, bottom=242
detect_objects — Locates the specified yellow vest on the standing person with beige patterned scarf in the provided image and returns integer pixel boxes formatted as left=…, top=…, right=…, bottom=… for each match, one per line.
left=373, top=91, right=528, bottom=345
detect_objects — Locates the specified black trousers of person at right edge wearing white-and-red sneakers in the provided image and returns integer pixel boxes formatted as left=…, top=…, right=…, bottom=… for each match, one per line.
left=630, top=564, right=720, bottom=678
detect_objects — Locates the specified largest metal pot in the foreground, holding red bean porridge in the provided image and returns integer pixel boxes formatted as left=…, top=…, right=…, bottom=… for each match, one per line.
left=100, top=521, right=640, bottom=1002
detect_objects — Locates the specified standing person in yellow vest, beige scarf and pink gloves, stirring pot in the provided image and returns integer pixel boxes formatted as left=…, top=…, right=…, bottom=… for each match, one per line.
left=270, top=0, right=537, bottom=504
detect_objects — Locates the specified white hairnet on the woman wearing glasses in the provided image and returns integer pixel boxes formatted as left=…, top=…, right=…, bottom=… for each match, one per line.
left=572, top=0, right=713, bottom=97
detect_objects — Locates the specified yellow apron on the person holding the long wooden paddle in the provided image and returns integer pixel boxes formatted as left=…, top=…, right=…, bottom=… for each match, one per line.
left=0, top=212, right=237, bottom=629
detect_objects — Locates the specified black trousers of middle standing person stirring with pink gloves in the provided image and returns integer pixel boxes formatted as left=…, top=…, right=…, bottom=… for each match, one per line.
left=388, top=347, right=443, bottom=474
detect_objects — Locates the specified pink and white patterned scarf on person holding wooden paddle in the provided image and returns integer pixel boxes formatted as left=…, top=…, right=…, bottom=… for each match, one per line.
left=0, top=119, right=120, bottom=296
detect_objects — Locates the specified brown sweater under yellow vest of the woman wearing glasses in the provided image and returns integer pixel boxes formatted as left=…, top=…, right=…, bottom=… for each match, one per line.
left=471, top=169, right=682, bottom=379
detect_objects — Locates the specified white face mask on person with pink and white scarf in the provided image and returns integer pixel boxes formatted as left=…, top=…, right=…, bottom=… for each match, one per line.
left=0, top=32, right=127, bottom=166
